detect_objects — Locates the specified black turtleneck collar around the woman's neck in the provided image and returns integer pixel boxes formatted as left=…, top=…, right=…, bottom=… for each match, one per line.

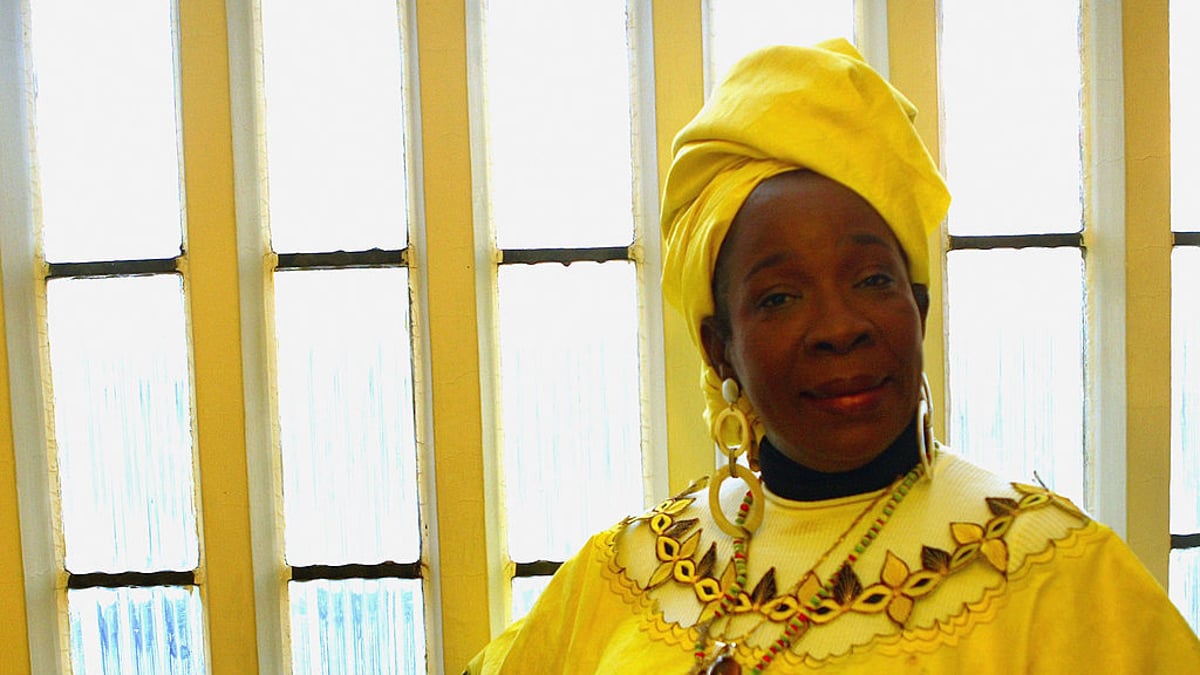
left=758, top=419, right=920, bottom=502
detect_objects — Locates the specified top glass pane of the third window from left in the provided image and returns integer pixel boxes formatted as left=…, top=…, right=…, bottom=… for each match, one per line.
left=484, top=0, right=634, bottom=249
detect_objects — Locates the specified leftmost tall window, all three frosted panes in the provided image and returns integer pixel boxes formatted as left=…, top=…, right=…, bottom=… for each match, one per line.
left=26, top=0, right=206, bottom=673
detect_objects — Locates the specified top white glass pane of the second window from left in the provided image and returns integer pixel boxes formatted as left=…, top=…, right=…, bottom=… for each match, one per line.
left=262, top=0, right=408, bottom=253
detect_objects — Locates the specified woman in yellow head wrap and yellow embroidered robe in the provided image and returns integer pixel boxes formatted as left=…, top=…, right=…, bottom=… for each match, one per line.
left=468, top=41, right=1200, bottom=674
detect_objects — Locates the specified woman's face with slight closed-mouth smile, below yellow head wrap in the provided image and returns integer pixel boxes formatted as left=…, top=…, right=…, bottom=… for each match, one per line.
left=701, top=172, right=924, bottom=471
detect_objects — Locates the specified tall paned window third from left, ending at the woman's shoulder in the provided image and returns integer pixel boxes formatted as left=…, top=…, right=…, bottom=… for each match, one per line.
left=476, top=0, right=665, bottom=617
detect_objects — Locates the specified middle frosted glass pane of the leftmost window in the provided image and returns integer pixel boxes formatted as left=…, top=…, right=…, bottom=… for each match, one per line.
left=47, top=274, right=198, bottom=574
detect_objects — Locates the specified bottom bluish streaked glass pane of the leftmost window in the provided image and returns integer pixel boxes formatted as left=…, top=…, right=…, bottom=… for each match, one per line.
left=67, top=586, right=206, bottom=675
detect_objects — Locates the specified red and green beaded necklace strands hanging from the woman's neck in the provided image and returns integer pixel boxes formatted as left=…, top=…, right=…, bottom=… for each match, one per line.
left=692, top=464, right=925, bottom=675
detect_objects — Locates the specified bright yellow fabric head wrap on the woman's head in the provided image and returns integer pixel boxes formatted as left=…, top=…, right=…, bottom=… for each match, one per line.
left=662, top=40, right=950, bottom=429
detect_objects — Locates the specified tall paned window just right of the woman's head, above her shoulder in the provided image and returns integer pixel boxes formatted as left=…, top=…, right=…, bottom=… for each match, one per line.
left=940, top=1, right=1092, bottom=504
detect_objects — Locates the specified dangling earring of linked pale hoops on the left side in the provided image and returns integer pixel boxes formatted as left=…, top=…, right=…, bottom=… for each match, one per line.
left=708, top=377, right=764, bottom=538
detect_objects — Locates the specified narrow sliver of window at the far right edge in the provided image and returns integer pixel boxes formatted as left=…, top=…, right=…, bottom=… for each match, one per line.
left=1169, top=0, right=1200, bottom=632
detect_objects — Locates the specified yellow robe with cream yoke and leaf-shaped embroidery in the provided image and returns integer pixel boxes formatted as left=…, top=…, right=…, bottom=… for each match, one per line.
left=468, top=453, right=1200, bottom=675
